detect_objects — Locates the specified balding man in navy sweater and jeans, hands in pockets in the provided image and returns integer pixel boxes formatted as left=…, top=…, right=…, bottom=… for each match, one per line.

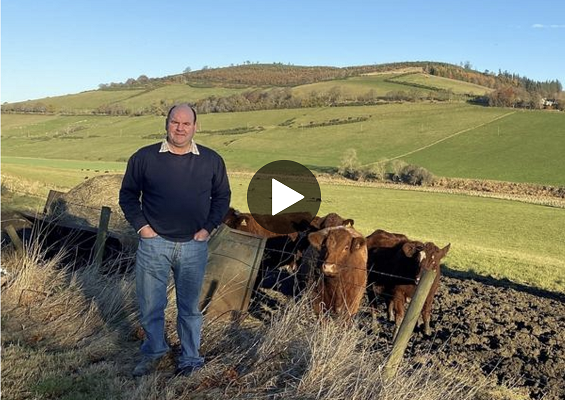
left=120, top=104, right=231, bottom=376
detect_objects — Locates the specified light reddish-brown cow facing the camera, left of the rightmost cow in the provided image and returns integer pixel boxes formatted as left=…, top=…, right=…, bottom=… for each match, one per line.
left=299, top=226, right=367, bottom=321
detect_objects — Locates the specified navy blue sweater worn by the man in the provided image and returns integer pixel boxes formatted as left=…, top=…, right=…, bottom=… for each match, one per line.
left=120, top=143, right=231, bottom=242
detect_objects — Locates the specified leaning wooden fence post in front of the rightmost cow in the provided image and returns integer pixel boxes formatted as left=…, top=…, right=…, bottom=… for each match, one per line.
left=384, top=270, right=437, bottom=380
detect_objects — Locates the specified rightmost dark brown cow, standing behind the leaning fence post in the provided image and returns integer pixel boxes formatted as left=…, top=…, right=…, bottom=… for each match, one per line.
left=367, top=231, right=450, bottom=337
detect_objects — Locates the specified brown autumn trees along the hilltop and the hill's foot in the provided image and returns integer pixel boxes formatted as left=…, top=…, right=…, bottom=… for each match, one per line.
left=2, top=61, right=565, bottom=116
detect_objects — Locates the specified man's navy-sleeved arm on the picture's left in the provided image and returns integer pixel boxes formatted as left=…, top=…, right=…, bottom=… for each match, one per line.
left=120, top=154, right=150, bottom=233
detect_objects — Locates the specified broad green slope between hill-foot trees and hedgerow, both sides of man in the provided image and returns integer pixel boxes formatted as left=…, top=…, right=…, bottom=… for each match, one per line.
left=2, top=103, right=565, bottom=186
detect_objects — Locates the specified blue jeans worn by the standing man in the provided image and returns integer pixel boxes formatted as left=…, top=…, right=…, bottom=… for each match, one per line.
left=135, top=236, right=208, bottom=368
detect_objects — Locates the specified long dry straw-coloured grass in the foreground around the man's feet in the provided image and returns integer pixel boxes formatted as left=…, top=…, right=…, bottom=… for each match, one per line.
left=2, top=234, right=520, bottom=400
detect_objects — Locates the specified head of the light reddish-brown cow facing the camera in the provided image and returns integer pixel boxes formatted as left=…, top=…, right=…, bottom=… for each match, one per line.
left=308, top=227, right=367, bottom=276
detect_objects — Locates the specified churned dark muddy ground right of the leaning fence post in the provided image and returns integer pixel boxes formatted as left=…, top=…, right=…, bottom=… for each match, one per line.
left=370, top=276, right=565, bottom=399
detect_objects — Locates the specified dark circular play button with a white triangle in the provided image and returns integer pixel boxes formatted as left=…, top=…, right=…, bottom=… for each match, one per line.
left=247, top=160, right=322, bottom=234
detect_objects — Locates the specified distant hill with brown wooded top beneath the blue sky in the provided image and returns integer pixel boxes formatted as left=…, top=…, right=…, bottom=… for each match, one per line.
left=2, top=62, right=512, bottom=115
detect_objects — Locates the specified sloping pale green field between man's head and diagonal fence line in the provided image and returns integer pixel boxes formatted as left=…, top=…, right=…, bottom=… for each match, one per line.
left=201, top=104, right=508, bottom=169
